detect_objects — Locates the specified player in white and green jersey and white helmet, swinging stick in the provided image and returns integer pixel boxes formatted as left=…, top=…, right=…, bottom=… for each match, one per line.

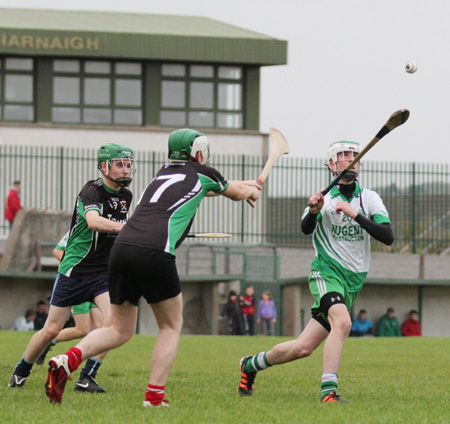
left=238, top=141, right=394, bottom=403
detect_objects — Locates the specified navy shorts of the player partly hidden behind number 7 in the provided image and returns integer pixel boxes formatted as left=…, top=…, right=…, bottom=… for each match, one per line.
left=49, top=273, right=109, bottom=307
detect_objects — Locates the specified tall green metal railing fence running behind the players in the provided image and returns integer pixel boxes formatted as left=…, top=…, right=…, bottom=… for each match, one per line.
left=0, top=145, right=450, bottom=253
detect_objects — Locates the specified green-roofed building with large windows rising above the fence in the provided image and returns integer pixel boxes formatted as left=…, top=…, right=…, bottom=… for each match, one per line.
left=0, top=8, right=287, bottom=154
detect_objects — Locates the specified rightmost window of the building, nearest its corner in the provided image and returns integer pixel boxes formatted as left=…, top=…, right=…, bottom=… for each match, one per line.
left=160, top=64, right=243, bottom=128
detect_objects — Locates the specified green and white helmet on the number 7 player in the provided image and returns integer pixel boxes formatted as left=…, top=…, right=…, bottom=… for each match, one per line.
left=168, top=128, right=209, bottom=163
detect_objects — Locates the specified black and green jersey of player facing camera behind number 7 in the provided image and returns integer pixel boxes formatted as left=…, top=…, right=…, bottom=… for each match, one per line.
left=58, top=178, right=132, bottom=279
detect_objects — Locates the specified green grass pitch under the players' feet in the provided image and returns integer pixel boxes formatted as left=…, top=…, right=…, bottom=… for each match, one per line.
left=0, top=331, right=450, bottom=424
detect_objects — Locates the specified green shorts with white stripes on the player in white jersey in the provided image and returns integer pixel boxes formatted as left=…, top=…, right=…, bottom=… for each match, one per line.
left=308, top=271, right=358, bottom=322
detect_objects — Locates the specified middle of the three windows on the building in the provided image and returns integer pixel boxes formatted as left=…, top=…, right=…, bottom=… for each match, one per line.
left=52, top=59, right=143, bottom=125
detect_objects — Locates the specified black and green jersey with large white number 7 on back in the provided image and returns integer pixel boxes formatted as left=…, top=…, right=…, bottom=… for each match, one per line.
left=116, top=162, right=228, bottom=255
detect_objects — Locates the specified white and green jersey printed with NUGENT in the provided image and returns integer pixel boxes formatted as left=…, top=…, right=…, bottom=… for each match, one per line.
left=303, top=183, right=390, bottom=292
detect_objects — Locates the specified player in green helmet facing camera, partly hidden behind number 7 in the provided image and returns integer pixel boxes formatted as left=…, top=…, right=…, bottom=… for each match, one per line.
left=8, top=143, right=134, bottom=398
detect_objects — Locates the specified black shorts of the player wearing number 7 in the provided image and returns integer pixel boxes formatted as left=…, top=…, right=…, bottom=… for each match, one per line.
left=109, top=243, right=181, bottom=306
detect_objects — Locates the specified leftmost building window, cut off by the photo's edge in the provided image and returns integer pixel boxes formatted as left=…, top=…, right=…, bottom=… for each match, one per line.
left=0, top=57, right=34, bottom=122
